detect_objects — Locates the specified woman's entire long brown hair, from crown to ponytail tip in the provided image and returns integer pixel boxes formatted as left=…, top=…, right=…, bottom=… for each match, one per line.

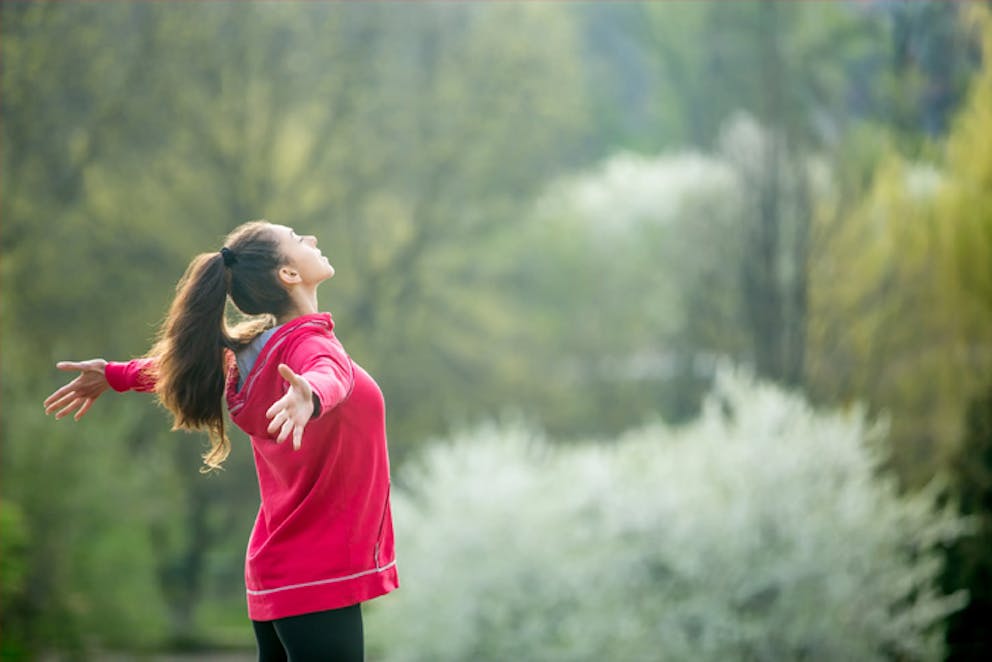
left=149, top=221, right=290, bottom=472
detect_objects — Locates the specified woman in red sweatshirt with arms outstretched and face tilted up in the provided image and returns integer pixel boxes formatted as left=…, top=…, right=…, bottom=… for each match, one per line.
left=45, top=221, right=399, bottom=662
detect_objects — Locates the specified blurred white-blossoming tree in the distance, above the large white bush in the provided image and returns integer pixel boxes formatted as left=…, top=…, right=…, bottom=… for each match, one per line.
left=520, top=151, right=746, bottom=384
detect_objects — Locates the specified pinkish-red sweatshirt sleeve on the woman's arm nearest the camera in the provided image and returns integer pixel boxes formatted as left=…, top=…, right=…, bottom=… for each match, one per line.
left=286, top=336, right=355, bottom=418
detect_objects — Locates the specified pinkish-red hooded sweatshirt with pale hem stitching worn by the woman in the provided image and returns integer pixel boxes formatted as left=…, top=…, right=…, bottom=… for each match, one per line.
left=106, top=313, right=399, bottom=621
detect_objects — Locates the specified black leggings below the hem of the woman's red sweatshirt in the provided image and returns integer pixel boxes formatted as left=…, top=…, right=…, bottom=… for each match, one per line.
left=251, top=604, right=365, bottom=662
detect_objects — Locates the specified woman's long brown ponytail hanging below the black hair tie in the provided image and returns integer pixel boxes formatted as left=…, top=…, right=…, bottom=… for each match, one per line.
left=150, top=253, right=232, bottom=473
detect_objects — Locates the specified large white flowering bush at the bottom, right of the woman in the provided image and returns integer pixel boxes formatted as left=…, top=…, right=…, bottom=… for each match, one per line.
left=367, top=371, right=964, bottom=662
